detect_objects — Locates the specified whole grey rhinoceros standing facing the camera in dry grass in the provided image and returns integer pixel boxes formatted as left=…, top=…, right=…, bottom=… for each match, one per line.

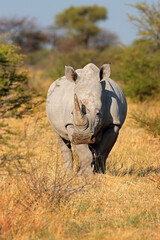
left=46, top=63, right=127, bottom=174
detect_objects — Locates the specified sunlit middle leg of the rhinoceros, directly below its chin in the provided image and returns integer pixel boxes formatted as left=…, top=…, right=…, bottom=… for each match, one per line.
left=73, top=144, right=93, bottom=175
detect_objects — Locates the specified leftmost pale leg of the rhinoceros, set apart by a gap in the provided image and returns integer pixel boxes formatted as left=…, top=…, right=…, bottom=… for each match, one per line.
left=58, top=136, right=73, bottom=172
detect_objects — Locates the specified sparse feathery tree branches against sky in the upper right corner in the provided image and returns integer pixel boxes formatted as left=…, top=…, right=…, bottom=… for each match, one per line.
left=128, top=1, right=160, bottom=47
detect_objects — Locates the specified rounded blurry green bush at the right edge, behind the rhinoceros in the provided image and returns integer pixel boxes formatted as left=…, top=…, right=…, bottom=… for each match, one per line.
left=119, top=40, right=160, bottom=101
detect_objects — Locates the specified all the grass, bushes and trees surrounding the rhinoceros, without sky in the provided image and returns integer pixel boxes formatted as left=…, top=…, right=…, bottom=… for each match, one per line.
left=0, top=1, right=160, bottom=240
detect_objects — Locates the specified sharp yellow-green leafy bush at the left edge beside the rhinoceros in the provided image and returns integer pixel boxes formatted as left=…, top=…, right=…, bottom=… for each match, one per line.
left=0, top=34, right=42, bottom=118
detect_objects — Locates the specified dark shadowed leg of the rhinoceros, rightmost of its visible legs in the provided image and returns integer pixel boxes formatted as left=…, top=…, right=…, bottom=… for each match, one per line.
left=93, top=125, right=120, bottom=173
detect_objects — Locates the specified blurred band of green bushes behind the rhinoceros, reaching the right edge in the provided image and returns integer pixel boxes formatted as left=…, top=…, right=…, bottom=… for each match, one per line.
left=24, top=39, right=160, bottom=101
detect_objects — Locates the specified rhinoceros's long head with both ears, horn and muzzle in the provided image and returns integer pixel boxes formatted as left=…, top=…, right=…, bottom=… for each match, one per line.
left=65, top=63, right=110, bottom=144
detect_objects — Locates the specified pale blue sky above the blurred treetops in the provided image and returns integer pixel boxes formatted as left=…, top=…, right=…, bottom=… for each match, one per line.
left=0, top=0, right=158, bottom=45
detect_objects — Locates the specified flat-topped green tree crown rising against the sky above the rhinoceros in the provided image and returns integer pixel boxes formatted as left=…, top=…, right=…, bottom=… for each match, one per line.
left=55, top=5, right=107, bottom=46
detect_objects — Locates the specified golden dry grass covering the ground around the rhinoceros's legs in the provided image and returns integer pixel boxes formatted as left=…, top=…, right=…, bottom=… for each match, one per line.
left=0, top=100, right=160, bottom=240
